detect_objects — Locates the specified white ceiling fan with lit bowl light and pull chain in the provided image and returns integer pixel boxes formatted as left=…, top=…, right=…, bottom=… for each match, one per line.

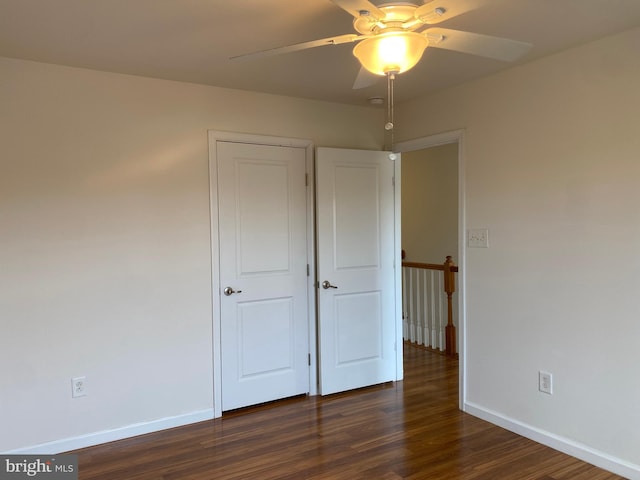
left=231, top=0, right=531, bottom=146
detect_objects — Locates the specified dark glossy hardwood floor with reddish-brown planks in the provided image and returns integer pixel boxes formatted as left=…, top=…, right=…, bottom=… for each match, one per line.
left=73, top=346, right=622, bottom=480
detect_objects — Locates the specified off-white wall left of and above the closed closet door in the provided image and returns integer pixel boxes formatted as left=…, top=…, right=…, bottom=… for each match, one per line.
left=0, top=59, right=383, bottom=451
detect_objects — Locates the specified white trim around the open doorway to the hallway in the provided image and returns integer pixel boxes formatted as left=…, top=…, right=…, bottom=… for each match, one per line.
left=395, top=130, right=467, bottom=411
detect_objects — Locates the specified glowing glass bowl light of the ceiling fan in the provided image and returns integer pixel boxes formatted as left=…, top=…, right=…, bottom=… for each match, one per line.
left=353, top=31, right=429, bottom=75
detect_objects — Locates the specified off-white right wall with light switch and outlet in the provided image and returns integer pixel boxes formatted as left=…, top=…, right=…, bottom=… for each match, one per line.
left=396, top=29, right=640, bottom=478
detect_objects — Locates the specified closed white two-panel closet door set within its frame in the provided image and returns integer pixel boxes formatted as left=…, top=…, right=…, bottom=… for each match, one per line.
left=216, top=141, right=309, bottom=410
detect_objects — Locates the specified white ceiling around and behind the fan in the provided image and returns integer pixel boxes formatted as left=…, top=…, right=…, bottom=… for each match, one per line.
left=0, top=0, right=640, bottom=104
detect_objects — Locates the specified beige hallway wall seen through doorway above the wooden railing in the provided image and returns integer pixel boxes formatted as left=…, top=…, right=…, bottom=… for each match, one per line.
left=402, top=143, right=458, bottom=263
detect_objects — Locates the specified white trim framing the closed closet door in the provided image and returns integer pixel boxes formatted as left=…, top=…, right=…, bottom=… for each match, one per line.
left=208, top=130, right=318, bottom=418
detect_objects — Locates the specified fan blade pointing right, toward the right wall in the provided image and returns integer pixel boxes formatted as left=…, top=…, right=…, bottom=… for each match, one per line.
left=423, top=27, right=532, bottom=62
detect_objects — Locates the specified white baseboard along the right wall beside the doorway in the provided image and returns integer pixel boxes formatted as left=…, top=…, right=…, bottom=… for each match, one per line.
left=464, top=402, right=640, bottom=480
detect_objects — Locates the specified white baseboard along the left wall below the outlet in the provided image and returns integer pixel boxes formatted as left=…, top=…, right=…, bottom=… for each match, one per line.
left=4, top=409, right=213, bottom=455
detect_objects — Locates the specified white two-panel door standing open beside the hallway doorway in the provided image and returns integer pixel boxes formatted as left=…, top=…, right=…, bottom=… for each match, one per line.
left=316, top=148, right=401, bottom=395
